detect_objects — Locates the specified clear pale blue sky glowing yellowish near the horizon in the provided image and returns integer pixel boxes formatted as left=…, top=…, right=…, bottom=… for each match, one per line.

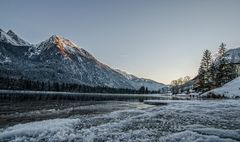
left=0, top=0, right=240, bottom=83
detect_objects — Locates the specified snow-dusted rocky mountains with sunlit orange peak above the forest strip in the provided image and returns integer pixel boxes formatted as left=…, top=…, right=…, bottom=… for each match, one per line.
left=0, top=29, right=167, bottom=91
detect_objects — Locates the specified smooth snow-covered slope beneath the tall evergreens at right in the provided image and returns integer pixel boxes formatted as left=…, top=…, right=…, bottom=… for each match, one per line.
left=201, top=77, right=240, bottom=98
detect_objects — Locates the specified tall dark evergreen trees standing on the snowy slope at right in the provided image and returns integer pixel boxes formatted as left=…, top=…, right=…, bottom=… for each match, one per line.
left=194, top=43, right=237, bottom=93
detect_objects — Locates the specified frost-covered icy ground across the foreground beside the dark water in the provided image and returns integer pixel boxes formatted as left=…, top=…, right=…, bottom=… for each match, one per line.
left=0, top=100, right=240, bottom=142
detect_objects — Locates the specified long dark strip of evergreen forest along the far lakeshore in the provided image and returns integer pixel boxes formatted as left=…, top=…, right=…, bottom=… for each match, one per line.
left=0, top=77, right=159, bottom=94
